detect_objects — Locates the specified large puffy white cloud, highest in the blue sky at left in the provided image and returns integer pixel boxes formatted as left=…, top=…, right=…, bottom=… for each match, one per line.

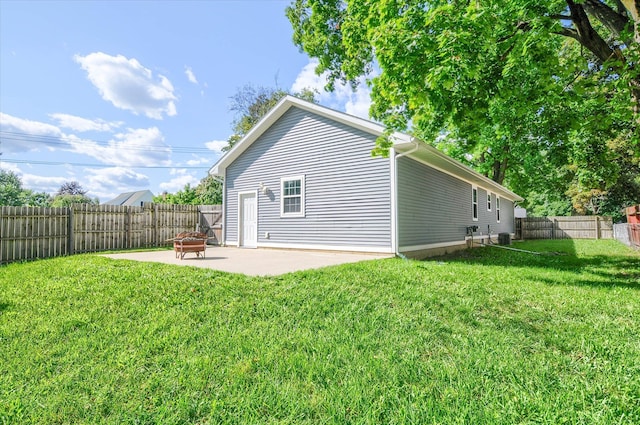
left=74, top=52, right=177, bottom=120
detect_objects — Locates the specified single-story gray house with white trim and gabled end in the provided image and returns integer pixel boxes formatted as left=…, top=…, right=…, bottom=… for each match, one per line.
left=209, top=96, right=522, bottom=258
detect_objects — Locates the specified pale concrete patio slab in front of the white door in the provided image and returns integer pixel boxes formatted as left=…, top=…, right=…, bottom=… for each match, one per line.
left=105, top=247, right=393, bottom=276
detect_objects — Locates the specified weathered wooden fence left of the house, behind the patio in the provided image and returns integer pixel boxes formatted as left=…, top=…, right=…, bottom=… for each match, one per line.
left=0, top=203, right=222, bottom=264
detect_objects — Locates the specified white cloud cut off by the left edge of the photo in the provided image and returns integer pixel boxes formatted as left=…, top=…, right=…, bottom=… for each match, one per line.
left=0, top=112, right=67, bottom=153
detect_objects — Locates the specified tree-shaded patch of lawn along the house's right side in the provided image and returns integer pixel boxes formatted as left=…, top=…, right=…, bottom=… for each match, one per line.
left=431, top=240, right=640, bottom=290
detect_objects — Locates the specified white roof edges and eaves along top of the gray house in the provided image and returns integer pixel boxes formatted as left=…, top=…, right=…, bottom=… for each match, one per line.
left=209, top=96, right=523, bottom=201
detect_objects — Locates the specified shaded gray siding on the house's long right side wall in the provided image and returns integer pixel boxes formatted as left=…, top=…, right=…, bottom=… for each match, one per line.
left=398, top=157, right=514, bottom=251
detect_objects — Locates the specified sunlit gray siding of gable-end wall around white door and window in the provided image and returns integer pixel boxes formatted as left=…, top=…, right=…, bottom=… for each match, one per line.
left=225, top=107, right=391, bottom=252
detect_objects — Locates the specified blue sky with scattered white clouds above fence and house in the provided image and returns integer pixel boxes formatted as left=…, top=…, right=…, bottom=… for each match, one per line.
left=0, top=0, right=370, bottom=202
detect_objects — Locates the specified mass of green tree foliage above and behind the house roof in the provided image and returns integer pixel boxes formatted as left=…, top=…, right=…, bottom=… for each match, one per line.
left=287, top=0, right=640, bottom=217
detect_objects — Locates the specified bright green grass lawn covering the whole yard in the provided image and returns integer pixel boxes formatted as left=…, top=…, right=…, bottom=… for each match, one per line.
left=0, top=241, right=640, bottom=425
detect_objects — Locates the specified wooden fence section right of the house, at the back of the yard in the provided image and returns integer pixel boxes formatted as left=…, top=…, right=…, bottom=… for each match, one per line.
left=516, top=216, right=613, bottom=239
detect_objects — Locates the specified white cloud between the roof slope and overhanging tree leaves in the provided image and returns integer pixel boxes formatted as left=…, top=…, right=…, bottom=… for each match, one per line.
left=291, top=59, right=371, bottom=119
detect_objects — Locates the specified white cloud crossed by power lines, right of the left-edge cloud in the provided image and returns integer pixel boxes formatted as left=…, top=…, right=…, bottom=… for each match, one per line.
left=72, top=127, right=171, bottom=166
